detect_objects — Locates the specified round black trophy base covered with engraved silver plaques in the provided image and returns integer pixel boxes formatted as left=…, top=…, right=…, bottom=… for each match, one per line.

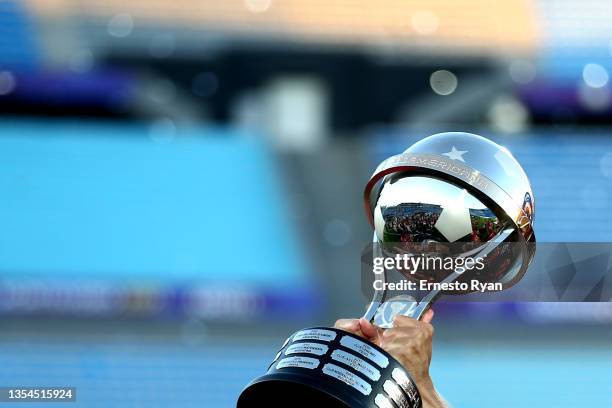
left=237, top=327, right=421, bottom=408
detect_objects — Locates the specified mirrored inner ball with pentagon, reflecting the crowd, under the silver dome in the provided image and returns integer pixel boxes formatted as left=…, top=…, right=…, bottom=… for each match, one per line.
left=374, top=177, right=512, bottom=288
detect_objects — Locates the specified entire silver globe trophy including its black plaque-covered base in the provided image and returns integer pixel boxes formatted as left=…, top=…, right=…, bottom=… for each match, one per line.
left=238, top=132, right=535, bottom=408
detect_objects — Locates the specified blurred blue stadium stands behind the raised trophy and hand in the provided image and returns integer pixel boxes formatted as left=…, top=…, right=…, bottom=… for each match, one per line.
left=0, top=0, right=612, bottom=408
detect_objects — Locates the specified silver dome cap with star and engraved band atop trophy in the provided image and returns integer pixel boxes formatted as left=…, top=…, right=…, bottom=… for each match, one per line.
left=365, top=132, right=535, bottom=245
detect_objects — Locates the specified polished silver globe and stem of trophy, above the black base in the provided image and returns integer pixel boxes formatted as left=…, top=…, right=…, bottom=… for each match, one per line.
left=365, top=132, right=535, bottom=327
